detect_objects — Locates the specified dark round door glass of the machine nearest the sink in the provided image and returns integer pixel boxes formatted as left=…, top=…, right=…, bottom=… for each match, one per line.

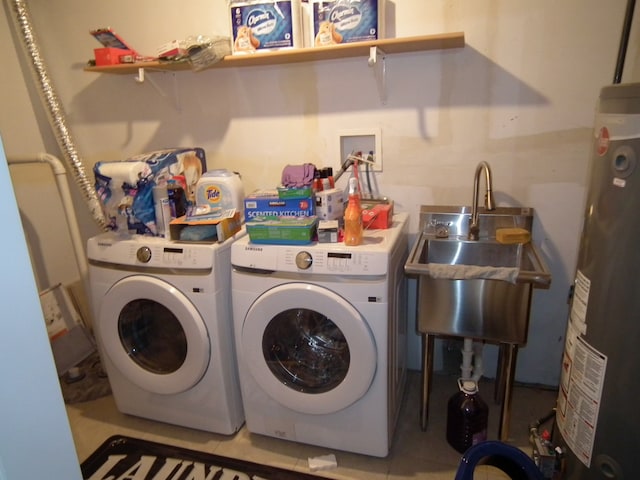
left=262, top=308, right=349, bottom=393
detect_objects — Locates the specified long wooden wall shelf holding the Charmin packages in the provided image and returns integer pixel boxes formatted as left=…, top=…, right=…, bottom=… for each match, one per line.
left=85, top=32, right=465, bottom=74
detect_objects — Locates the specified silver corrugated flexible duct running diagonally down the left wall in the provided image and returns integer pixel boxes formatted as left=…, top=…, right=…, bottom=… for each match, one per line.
left=10, top=0, right=108, bottom=230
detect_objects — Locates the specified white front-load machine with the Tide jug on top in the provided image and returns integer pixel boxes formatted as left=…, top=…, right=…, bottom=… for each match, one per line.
left=87, top=233, right=244, bottom=434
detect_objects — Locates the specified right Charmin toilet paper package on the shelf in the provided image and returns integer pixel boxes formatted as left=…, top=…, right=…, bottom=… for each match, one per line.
left=302, top=0, right=385, bottom=47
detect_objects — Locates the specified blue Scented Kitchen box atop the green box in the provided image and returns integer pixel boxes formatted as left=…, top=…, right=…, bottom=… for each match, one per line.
left=244, top=190, right=315, bottom=222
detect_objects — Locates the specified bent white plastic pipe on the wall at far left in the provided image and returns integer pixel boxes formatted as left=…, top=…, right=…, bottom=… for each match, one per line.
left=7, top=153, right=89, bottom=304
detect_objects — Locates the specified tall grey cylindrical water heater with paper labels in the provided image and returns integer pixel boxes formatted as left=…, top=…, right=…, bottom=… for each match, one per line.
left=554, top=83, right=640, bottom=480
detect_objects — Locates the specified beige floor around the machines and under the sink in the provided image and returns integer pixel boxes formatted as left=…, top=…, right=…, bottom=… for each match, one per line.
left=67, top=371, right=556, bottom=480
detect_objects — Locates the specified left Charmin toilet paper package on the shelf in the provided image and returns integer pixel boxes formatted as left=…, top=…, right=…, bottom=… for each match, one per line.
left=229, top=0, right=303, bottom=55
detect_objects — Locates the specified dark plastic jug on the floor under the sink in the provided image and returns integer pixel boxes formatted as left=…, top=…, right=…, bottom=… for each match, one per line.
left=447, top=379, right=489, bottom=453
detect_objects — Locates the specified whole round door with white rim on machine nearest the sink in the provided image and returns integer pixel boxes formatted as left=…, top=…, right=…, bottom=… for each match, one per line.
left=241, top=283, right=377, bottom=414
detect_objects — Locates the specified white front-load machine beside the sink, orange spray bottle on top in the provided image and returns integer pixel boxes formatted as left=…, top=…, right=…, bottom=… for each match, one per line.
left=231, top=214, right=408, bottom=457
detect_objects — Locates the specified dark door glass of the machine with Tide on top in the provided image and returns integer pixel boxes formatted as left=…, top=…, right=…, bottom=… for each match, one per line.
left=118, top=299, right=187, bottom=374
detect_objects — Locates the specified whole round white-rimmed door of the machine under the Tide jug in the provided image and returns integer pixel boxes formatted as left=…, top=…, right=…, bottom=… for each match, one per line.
left=96, top=275, right=211, bottom=394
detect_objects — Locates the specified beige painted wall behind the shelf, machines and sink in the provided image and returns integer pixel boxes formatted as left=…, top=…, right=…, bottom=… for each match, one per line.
left=0, top=0, right=640, bottom=384
